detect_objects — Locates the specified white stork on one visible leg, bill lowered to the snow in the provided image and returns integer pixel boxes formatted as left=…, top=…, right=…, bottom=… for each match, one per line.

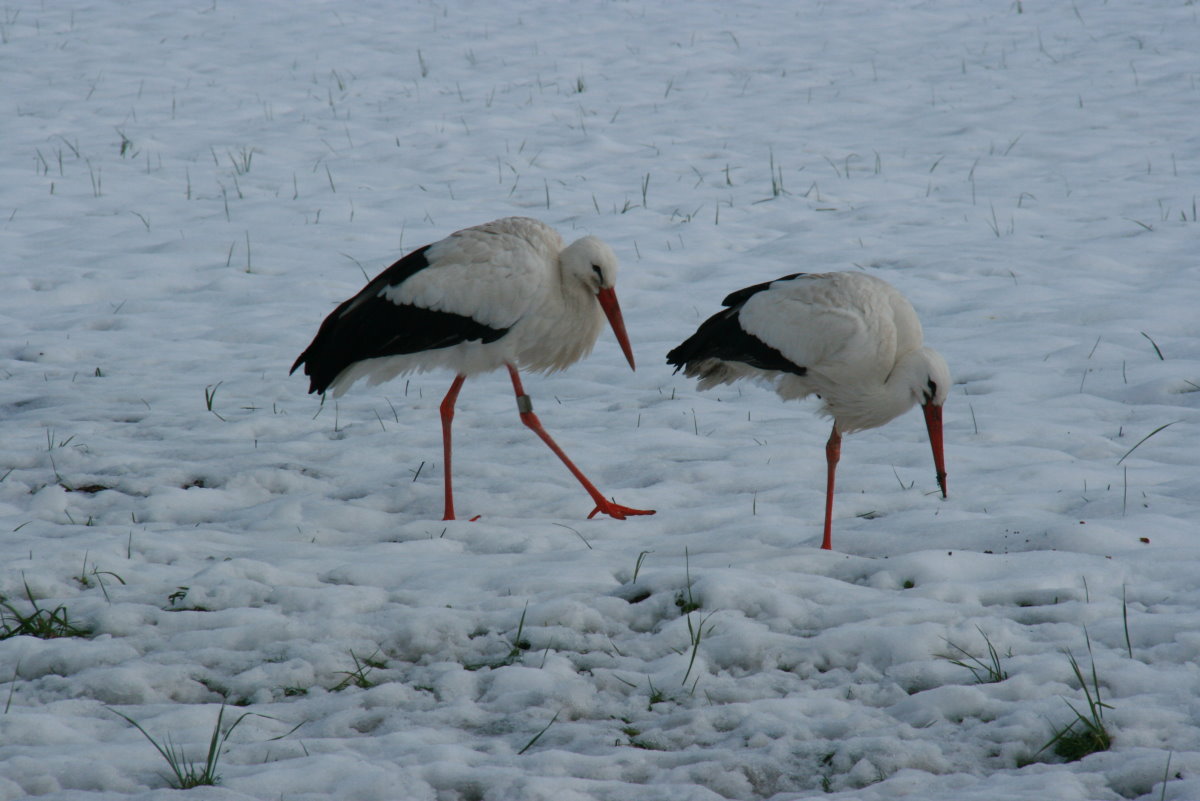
left=667, top=272, right=950, bottom=550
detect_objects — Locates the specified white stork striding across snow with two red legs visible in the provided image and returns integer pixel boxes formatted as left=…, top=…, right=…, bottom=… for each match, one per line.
left=292, top=217, right=654, bottom=520
